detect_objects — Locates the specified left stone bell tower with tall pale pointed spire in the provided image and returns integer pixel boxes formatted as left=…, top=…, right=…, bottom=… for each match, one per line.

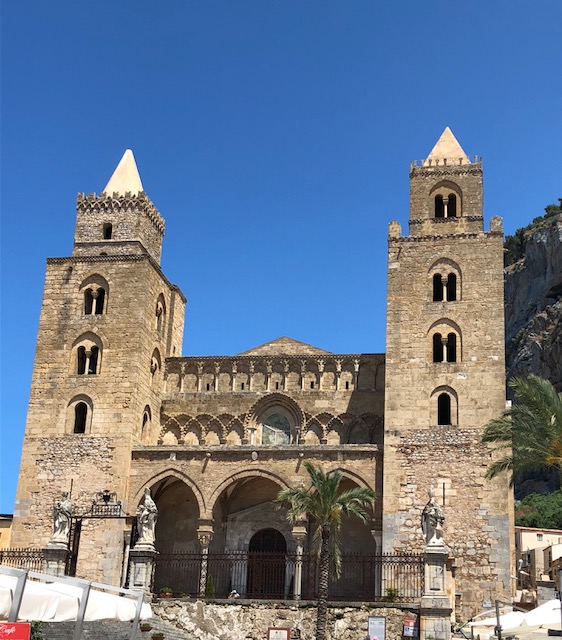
left=12, top=150, right=185, bottom=584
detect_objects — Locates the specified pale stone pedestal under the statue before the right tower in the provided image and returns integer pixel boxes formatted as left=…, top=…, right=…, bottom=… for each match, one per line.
left=420, top=544, right=453, bottom=640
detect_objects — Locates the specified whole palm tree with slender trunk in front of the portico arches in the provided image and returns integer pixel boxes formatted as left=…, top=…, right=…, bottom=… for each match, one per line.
left=275, top=462, right=375, bottom=640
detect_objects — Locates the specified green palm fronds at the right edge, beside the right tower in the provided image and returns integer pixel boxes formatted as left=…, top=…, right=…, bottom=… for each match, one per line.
left=476, top=375, right=562, bottom=484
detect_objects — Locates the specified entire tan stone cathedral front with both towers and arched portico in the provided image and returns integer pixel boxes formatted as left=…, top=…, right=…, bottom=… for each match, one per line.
left=12, top=129, right=513, bottom=612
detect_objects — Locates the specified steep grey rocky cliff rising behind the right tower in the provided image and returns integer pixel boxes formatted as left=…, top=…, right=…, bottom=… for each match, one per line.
left=505, top=214, right=562, bottom=391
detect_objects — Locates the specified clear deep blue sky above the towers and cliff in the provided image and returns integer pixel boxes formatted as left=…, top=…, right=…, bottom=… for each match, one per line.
left=0, top=0, right=562, bottom=513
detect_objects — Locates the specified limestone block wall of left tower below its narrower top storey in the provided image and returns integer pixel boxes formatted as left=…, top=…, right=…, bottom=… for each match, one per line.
left=12, top=254, right=185, bottom=582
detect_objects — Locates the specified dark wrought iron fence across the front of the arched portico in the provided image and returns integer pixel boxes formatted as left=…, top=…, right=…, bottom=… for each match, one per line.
left=153, top=552, right=423, bottom=602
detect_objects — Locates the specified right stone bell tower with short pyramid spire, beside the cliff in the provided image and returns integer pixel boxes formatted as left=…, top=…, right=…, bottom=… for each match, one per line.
left=383, top=128, right=513, bottom=615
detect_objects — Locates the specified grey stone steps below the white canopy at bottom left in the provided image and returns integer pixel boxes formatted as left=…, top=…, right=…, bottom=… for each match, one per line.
left=41, top=617, right=191, bottom=640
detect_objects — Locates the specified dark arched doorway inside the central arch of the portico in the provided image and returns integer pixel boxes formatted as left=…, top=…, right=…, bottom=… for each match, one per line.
left=247, top=529, right=287, bottom=598
